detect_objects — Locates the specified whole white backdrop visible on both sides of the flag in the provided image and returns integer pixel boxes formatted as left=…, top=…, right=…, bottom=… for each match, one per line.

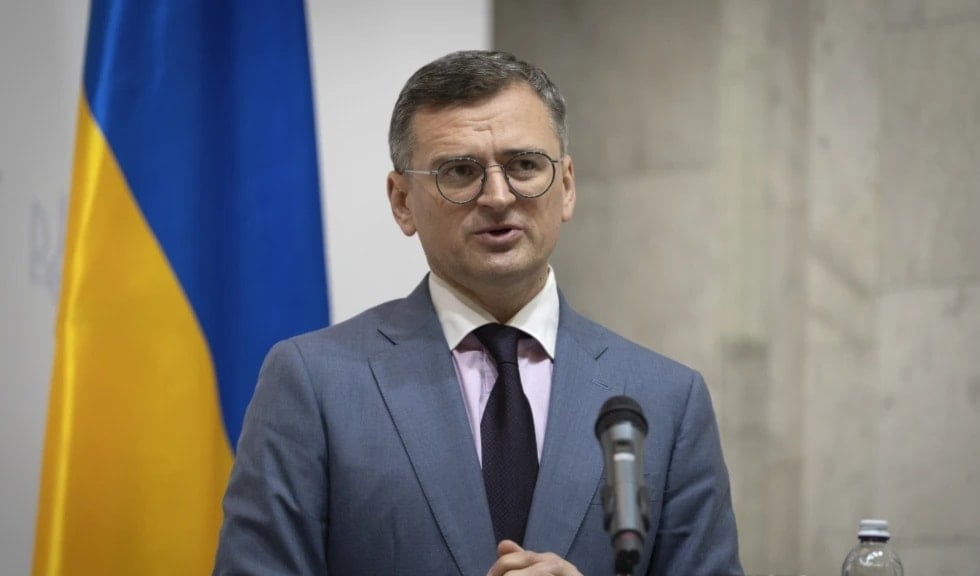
left=0, top=0, right=490, bottom=575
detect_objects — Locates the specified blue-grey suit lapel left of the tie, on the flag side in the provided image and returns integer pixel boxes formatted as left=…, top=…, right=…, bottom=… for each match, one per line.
left=370, top=279, right=496, bottom=575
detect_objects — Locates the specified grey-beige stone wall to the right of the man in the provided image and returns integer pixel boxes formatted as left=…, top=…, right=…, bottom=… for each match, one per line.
left=494, top=0, right=980, bottom=576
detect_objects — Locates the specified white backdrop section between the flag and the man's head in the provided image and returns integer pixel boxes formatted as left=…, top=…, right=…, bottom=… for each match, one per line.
left=307, top=0, right=491, bottom=321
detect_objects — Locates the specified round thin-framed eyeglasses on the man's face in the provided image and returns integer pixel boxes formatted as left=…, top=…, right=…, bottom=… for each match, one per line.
left=401, top=152, right=561, bottom=204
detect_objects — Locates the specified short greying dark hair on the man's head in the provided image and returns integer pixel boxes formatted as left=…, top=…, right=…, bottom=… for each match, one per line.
left=388, top=50, right=568, bottom=170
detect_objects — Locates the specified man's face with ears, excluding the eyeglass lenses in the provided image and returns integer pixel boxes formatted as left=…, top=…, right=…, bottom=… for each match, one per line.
left=388, top=84, right=575, bottom=302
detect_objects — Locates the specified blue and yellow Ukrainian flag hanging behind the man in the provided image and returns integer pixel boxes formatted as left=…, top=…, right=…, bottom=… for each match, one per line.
left=33, top=0, right=327, bottom=576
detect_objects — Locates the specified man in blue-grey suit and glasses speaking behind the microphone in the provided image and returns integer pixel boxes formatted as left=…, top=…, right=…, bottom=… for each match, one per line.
left=214, top=51, right=741, bottom=576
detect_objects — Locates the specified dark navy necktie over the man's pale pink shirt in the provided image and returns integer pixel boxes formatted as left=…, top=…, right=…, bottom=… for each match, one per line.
left=473, top=324, right=538, bottom=544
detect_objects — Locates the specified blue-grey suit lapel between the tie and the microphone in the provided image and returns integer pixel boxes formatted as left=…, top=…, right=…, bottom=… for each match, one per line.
left=524, top=297, right=622, bottom=557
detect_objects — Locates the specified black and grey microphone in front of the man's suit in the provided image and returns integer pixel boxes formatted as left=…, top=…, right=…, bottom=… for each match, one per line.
left=595, top=396, right=650, bottom=575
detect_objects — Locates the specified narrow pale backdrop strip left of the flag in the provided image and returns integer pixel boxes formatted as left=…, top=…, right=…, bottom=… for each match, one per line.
left=0, top=0, right=88, bottom=576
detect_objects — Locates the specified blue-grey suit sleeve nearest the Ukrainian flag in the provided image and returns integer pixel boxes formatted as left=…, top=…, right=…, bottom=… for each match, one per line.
left=214, top=341, right=327, bottom=576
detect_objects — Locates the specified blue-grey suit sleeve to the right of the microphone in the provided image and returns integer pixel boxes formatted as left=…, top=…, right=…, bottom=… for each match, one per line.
left=648, top=372, right=742, bottom=576
